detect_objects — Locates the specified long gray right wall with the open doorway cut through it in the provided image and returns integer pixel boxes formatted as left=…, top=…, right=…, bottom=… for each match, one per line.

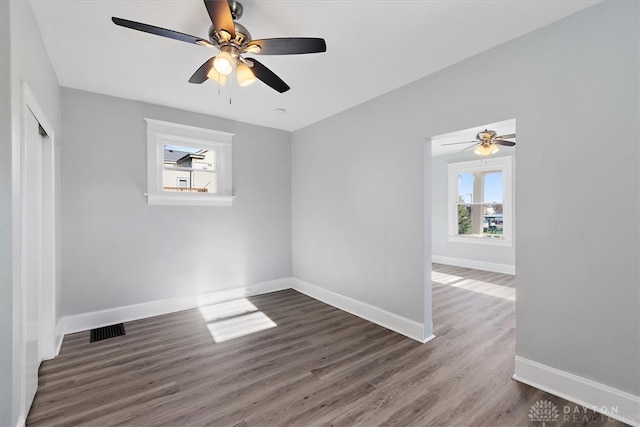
left=292, top=2, right=640, bottom=395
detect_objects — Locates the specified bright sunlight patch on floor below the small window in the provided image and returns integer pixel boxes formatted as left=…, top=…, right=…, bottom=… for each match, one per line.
left=200, top=298, right=278, bottom=343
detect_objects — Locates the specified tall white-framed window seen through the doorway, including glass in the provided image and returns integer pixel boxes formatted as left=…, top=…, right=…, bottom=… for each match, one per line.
left=449, top=157, right=514, bottom=246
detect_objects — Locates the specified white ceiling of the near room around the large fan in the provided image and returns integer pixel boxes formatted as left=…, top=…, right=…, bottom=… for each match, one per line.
left=31, top=0, right=597, bottom=131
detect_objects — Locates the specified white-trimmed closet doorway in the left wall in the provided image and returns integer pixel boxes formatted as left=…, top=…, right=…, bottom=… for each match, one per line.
left=14, top=83, right=56, bottom=419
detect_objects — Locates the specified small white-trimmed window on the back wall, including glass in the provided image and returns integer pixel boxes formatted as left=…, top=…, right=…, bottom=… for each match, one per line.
left=145, top=119, right=233, bottom=206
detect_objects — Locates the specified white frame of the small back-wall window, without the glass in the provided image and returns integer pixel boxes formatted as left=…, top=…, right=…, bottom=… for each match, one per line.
left=144, top=119, right=235, bottom=206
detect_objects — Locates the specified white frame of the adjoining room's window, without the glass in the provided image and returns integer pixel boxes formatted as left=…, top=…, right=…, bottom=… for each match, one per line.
left=448, top=156, right=515, bottom=246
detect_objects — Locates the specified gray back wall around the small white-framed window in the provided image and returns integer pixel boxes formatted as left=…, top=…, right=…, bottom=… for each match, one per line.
left=62, top=88, right=291, bottom=315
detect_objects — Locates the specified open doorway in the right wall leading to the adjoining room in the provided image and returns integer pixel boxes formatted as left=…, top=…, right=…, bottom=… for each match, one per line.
left=425, top=119, right=516, bottom=342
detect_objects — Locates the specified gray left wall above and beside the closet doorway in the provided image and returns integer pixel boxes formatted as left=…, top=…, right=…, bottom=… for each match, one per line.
left=0, top=1, right=61, bottom=426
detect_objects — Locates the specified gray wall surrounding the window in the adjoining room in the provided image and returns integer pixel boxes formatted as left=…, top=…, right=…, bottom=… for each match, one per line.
left=431, top=152, right=517, bottom=266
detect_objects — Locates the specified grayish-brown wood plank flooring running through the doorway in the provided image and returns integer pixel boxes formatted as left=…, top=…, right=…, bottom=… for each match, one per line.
left=27, top=264, right=624, bottom=427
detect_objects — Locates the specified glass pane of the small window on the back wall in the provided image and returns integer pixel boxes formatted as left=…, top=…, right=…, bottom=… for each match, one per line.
left=162, top=145, right=218, bottom=193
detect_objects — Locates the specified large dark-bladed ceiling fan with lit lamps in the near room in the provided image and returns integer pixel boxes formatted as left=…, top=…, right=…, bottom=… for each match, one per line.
left=111, top=0, right=327, bottom=93
